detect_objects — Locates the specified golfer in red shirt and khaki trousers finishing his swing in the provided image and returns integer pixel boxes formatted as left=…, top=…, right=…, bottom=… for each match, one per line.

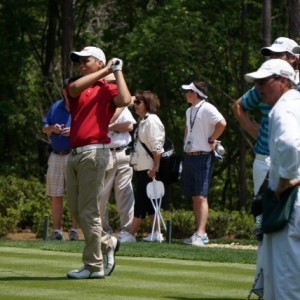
left=67, top=47, right=131, bottom=279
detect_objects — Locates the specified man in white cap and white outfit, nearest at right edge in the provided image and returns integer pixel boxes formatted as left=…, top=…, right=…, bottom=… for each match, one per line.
left=245, top=59, right=300, bottom=300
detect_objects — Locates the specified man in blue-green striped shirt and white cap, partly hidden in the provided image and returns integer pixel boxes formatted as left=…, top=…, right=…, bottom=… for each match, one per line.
left=233, top=37, right=299, bottom=296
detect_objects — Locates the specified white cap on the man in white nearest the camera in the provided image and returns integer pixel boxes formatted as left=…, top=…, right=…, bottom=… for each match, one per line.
left=245, top=58, right=297, bottom=84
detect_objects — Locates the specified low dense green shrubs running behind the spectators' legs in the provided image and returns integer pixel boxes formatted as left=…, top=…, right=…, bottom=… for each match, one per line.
left=0, top=176, right=254, bottom=239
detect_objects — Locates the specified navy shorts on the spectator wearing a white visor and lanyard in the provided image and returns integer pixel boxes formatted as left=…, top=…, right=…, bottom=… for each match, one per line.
left=182, top=153, right=215, bottom=197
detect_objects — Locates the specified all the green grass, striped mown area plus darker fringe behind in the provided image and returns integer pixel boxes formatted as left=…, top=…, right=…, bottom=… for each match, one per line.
left=0, top=240, right=256, bottom=300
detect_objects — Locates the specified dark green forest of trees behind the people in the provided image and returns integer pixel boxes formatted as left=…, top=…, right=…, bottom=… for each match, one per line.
left=0, top=0, right=300, bottom=220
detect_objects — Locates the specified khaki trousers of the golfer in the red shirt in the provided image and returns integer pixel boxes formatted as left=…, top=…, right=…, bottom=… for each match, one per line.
left=67, top=149, right=113, bottom=272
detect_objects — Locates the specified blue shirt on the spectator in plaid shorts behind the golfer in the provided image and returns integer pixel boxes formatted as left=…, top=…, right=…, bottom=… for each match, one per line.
left=43, top=99, right=71, bottom=152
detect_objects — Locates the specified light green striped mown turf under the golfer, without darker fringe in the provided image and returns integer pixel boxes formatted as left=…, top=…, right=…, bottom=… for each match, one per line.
left=0, top=247, right=255, bottom=300
